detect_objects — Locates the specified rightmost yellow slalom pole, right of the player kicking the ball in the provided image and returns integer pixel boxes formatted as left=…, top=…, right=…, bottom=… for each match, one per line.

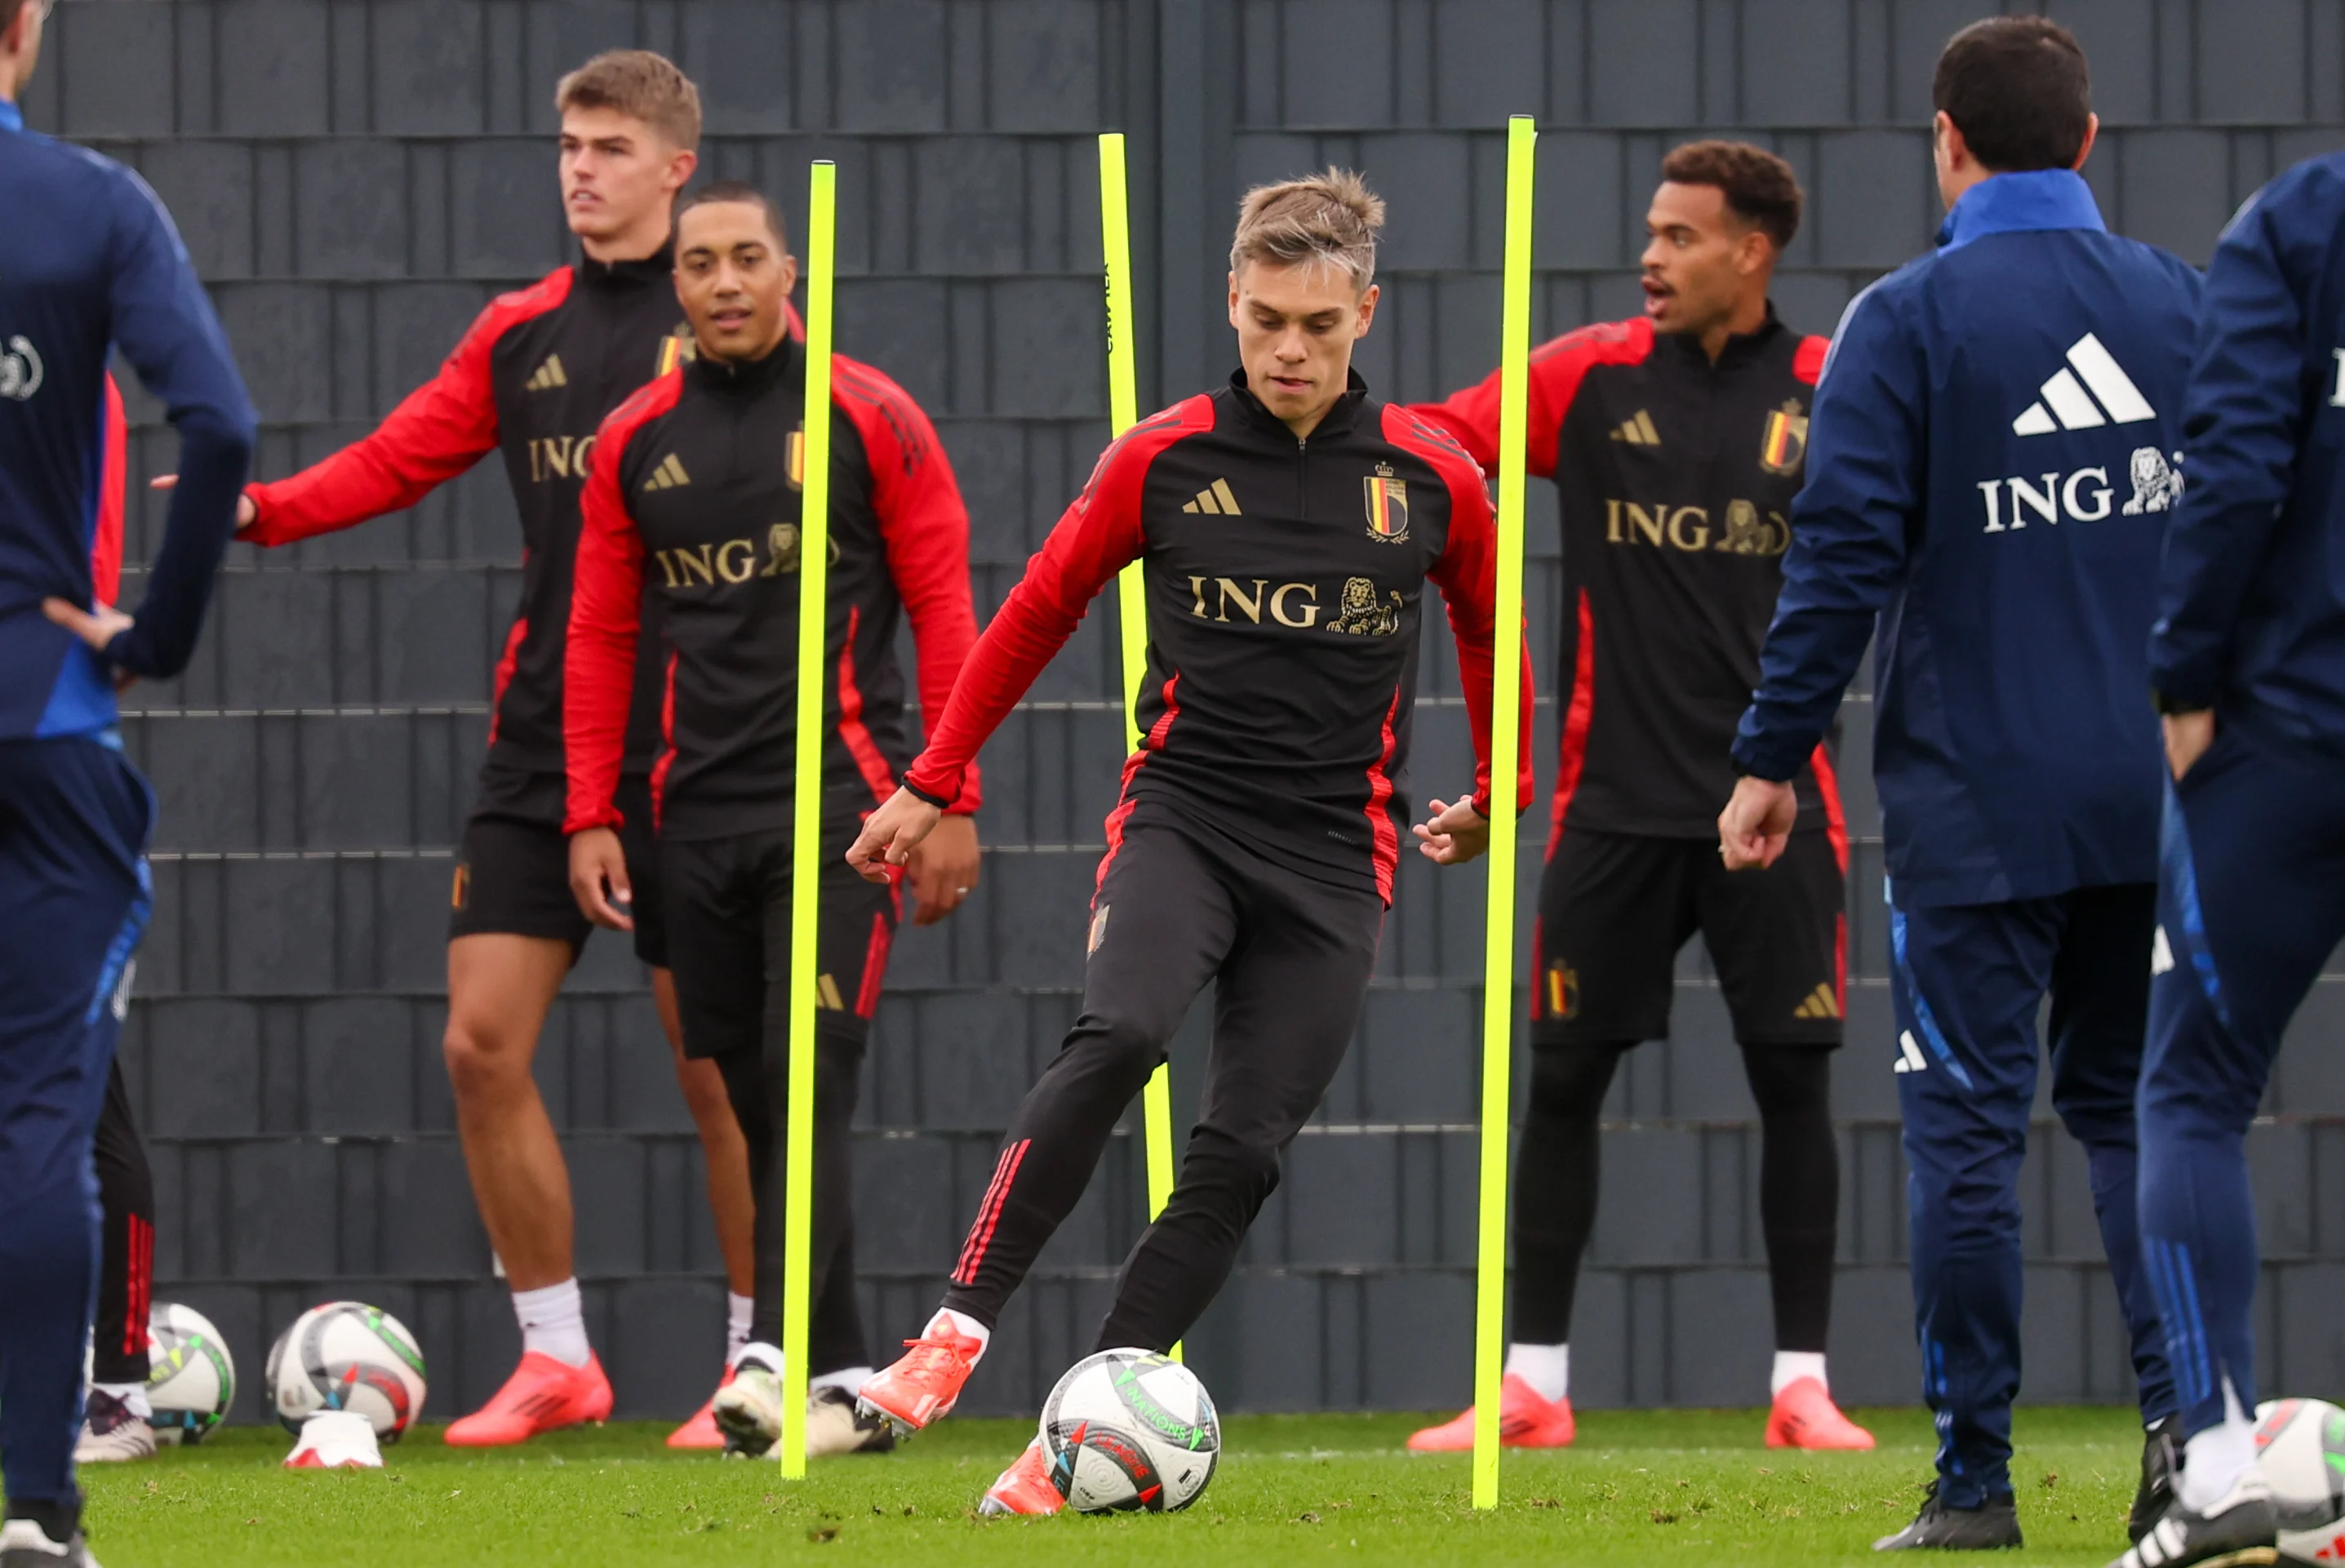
left=1472, top=115, right=1539, bottom=1507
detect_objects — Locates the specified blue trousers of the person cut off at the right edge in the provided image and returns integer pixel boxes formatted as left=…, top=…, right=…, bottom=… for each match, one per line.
left=2141, top=715, right=2345, bottom=1434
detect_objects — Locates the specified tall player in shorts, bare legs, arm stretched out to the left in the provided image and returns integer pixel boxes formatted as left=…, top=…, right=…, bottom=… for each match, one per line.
left=158, top=49, right=863, bottom=1449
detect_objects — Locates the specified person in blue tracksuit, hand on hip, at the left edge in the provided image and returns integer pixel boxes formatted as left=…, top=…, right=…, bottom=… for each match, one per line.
left=0, top=0, right=253, bottom=1568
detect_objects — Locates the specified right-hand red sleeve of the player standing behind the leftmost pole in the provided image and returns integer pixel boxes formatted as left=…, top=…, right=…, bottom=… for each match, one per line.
left=833, top=356, right=983, bottom=815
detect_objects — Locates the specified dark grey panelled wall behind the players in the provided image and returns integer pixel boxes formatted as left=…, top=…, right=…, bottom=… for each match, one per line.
left=28, top=0, right=2345, bottom=1415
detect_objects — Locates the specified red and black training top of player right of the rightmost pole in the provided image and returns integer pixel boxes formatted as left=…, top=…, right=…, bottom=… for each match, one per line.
left=1416, top=307, right=1841, bottom=853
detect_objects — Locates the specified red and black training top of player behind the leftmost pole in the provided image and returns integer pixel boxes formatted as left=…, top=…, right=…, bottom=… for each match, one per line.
left=563, top=342, right=978, bottom=839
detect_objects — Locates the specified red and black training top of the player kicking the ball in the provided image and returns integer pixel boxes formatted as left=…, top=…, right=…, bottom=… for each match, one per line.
left=905, top=373, right=1531, bottom=900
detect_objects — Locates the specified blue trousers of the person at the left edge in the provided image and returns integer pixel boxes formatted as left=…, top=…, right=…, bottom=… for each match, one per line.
left=0, top=739, right=155, bottom=1509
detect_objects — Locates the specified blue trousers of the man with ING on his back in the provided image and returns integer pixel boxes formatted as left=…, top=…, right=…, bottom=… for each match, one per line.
left=1890, top=884, right=2174, bottom=1507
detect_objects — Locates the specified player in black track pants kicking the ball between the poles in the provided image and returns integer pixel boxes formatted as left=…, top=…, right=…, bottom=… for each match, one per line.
left=849, top=169, right=1531, bottom=1514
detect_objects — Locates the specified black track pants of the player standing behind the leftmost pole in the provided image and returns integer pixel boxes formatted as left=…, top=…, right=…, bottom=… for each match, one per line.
left=659, top=832, right=895, bottom=1376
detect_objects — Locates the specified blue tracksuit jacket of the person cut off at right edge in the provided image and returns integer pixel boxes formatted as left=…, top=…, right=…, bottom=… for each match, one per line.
left=2151, top=153, right=2345, bottom=745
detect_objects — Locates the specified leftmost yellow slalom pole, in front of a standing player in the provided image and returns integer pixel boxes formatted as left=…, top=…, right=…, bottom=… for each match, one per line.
left=776, top=159, right=840, bottom=1481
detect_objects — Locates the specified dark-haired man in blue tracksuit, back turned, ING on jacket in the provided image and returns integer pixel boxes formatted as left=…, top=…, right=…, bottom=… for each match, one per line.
left=1719, top=16, right=2200, bottom=1549
